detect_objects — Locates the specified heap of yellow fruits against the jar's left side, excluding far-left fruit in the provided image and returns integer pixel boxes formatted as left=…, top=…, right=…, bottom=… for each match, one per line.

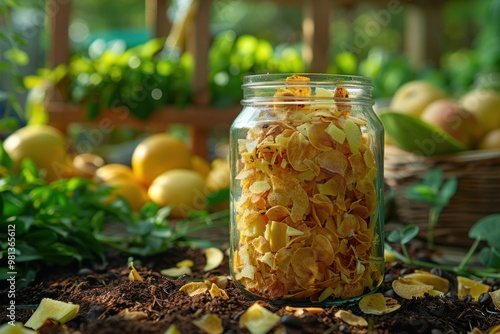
left=95, top=133, right=229, bottom=218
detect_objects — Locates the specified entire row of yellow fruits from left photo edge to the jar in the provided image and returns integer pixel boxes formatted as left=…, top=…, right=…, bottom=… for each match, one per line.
left=3, top=125, right=229, bottom=218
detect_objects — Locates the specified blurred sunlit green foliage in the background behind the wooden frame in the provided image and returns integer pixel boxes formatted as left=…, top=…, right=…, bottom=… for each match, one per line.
left=14, top=0, right=500, bottom=119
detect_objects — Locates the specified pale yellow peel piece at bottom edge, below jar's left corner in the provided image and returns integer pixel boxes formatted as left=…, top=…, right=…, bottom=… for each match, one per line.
left=240, top=302, right=281, bottom=334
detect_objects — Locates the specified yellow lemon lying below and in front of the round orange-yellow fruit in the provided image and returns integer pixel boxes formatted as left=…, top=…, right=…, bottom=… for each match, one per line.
left=148, top=169, right=206, bottom=218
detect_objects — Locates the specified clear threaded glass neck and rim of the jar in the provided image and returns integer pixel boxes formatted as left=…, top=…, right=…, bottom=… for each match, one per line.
left=241, top=73, right=373, bottom=106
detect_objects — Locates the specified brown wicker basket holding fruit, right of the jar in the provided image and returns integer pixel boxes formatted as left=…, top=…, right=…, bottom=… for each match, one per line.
left=384, top=145, right=500, bottom=247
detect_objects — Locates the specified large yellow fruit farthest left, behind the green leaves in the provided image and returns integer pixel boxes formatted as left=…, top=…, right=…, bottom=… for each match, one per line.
left=3, top=125, right=70, bottom=181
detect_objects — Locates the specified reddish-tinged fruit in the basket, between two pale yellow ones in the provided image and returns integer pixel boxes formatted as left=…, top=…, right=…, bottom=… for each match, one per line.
left=420, top=99, right=483, bottom=148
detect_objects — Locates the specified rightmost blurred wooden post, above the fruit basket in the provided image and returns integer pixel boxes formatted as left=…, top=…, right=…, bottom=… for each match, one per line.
left=404, top=1, right=443, bottom=69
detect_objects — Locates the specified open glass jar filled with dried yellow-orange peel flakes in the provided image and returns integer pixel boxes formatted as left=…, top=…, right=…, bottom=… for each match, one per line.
left=230, top=74, right=384, bottom=305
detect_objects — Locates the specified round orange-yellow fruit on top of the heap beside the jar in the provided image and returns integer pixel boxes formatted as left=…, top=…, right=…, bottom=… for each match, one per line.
left=132, top=133, right=191, bottom=187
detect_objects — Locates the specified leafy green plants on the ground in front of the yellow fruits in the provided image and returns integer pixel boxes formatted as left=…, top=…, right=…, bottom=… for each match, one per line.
left=0, top=145, right=228, bottom=286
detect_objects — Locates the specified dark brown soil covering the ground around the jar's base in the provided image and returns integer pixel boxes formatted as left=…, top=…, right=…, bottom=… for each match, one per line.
left=0, top=241, right=500, bottom=334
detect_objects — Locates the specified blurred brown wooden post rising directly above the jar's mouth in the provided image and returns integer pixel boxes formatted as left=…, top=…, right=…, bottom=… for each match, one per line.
left=302, top=0, right=331, bottom=72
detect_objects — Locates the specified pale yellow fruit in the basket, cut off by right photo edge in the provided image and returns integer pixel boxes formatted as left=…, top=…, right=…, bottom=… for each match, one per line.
left=459, top=89, right=500, bottom=134
